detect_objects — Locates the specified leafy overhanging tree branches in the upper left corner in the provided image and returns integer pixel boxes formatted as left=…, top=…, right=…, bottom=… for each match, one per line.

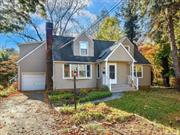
left=0, top=0, right=45, bottom=33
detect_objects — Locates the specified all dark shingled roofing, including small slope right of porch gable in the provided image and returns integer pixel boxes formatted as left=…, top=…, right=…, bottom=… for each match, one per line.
left=52, top=36, right=150, bottom=64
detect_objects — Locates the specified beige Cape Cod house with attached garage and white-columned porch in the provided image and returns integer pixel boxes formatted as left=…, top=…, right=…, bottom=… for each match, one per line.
left=17, top=24, right=151, bottom=92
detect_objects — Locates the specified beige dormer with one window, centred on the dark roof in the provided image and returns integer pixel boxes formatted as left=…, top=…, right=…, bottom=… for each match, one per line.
left=72, top=34, right=94, bottom=57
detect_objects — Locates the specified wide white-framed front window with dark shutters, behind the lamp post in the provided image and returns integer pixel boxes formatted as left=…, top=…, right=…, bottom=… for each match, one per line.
left=63, top=64, right=91, bottom=79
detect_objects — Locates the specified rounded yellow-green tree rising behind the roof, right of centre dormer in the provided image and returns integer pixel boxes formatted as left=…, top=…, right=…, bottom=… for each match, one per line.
left=97, top=17, right=122, bottom=41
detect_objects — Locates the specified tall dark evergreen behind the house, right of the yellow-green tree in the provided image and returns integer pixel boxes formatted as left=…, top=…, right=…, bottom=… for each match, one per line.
left=116, top=0, right=139, bottom=42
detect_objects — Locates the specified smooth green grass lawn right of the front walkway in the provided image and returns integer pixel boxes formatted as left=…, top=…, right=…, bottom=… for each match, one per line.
left=107, top=89, right=180, bottom=129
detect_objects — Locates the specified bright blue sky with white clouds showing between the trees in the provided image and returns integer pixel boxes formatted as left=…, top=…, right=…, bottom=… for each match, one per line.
left=0, top=0, right=119, bottom=50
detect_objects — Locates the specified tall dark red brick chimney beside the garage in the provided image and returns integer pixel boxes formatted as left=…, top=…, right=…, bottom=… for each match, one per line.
left=46, top=22, right=53, bottom=91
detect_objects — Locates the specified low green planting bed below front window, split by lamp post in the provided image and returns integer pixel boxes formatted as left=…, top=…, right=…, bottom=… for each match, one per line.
left=48, top=90, right=112, bottom=106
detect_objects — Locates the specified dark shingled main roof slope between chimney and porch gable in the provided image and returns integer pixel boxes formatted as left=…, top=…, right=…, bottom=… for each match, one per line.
left=53, top=36, right=114, bottom=62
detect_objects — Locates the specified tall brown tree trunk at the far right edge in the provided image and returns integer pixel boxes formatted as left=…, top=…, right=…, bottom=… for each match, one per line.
left=168, top=15, right=180, bottom=90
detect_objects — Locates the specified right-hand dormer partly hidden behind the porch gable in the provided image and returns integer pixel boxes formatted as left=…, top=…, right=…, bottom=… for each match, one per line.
left=121, top=37, right=134, bottom=56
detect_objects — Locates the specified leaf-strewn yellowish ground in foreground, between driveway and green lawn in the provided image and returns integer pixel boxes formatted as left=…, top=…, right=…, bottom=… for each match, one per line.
left=56, top=103, right=178, bottom=135
